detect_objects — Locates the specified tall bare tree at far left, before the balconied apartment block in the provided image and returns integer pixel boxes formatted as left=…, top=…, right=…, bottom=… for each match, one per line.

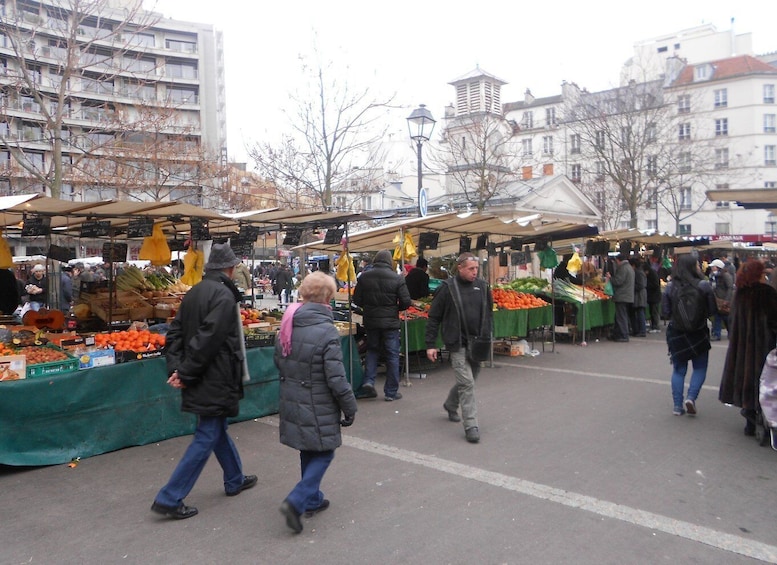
left=0, top=0, right=164, bottom=197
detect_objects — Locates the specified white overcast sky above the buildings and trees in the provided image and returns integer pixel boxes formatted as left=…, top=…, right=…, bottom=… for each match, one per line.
left=144, top=0, right=777, bottom=161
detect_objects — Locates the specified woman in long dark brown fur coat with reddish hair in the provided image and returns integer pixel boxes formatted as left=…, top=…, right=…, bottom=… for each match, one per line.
left=718, top=259, right=777, bottom=436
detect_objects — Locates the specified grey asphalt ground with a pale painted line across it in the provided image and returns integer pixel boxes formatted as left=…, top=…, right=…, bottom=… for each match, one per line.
left=0, top=328, right=777, bottom=565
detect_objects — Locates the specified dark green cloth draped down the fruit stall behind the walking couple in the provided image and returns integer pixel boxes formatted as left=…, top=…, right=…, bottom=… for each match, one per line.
left=0, top=336, right=362, bottom=466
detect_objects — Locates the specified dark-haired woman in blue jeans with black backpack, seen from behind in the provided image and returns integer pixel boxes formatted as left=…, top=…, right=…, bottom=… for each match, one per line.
left=661, top=254, right=717, bottom=416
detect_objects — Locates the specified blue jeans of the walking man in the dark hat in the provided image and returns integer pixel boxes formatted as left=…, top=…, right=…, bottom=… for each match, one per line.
left=155, top=416, right=245, bottom=507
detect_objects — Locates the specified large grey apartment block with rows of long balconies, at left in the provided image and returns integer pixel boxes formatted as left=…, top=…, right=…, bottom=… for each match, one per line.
left=0, top=0, right=227, bottom=208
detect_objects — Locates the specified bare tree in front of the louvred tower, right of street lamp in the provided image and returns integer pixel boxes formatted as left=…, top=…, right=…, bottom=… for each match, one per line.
left=443, top=113, right=518, bottom=211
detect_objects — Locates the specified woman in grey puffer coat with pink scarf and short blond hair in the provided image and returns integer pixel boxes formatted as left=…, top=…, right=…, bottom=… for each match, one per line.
left=275, top=271, right=356, bottom=533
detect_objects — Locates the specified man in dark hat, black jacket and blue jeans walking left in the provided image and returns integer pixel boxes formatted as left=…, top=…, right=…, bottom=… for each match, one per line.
left=151, top=244, right=257, bottom=519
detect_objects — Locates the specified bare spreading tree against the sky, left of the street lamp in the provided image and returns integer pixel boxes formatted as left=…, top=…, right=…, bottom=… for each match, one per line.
left=249, top=51, right=392, bottom=210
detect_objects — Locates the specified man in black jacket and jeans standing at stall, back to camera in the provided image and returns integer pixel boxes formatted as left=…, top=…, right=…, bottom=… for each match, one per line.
left=353, top=249, right=412, bottom=401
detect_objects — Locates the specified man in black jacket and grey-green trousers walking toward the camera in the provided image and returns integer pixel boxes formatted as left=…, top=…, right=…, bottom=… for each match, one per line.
left=425, top=253, right=494, bottom=443
